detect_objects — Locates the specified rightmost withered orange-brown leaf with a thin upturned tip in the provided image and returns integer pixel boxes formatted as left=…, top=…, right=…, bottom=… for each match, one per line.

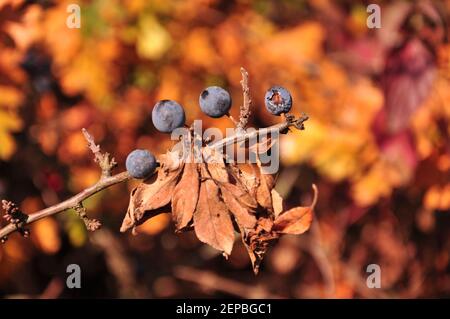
left=273, top=185, right=317, bottom=235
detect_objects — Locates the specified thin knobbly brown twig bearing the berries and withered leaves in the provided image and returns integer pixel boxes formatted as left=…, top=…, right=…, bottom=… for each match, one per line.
left=0, top=68, right=308, bottom=242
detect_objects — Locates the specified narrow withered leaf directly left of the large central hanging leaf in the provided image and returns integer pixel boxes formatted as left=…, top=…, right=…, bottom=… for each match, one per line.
left=172, top=163, right=200, bottom=230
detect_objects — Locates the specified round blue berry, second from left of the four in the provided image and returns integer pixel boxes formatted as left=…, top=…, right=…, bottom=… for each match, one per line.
left=152, top=100, right=186, bottom=133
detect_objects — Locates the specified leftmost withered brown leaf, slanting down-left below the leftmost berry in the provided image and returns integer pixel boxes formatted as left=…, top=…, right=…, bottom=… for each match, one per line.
left=120, top=159, right=183, bottom=232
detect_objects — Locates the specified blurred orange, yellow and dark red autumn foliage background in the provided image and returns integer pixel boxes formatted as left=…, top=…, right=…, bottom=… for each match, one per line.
left=0, top=0, right=450, bottom=298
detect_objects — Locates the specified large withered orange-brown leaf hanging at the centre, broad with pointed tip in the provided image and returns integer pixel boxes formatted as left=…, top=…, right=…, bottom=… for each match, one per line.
left=194, top=164, right=234, bottom=256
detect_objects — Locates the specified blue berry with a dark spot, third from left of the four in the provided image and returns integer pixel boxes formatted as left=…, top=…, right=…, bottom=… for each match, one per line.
left=198, top=86, right=231, bottom=118
